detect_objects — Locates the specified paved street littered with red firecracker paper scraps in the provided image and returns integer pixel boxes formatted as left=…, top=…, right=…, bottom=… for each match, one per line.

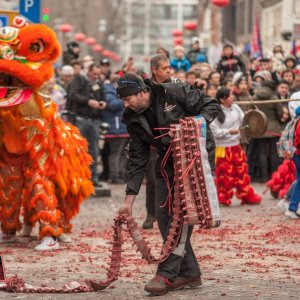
left=0, top=185, right=300, bottom=300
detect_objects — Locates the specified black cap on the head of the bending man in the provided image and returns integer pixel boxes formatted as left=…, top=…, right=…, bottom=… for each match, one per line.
left=115, top=74, right=147, bottom=98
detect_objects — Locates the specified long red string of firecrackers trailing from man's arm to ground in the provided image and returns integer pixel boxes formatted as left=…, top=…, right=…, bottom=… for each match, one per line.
left=5, top=118, right=219, bottom=293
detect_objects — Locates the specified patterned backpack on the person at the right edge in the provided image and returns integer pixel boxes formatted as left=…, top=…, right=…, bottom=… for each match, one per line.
left=277, top=117, right=300, bottom=159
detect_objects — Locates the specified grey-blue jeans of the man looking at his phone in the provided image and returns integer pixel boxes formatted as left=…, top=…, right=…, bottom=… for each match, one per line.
left=76, top=118, right=101, bottom=183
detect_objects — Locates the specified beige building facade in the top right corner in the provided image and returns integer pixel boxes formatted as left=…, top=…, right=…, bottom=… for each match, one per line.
left=222, top=0, right=300, bottom=54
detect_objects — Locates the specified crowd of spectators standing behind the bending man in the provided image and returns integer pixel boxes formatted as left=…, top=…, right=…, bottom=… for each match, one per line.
left=50, top=37, right=300, bottom=192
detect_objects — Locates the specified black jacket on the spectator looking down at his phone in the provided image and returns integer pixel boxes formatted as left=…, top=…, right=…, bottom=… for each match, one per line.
left=66, top=75, right=102, bottom=119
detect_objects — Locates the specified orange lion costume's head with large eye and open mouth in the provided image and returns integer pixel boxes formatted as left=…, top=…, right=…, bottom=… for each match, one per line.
left=0, top=17, right=60, bottom=107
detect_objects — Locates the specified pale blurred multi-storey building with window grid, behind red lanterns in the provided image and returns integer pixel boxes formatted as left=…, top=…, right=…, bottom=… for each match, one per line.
left=121, top=0, right=199, bottom=67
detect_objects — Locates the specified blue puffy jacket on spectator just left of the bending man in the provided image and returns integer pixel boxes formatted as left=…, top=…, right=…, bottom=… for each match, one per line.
left=100, top=83, right=127, bottom=135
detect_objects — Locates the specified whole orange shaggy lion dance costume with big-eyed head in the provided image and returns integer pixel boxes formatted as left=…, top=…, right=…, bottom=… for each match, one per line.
left=0, top=17, right=93, bottom=244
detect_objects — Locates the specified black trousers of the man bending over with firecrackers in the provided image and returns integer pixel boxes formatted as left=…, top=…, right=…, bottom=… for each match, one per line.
left=155, top=178, right=201, bottom=281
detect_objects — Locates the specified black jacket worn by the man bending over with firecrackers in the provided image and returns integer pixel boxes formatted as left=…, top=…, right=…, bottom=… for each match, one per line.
left=123, top=80, right=221, bottom=195
